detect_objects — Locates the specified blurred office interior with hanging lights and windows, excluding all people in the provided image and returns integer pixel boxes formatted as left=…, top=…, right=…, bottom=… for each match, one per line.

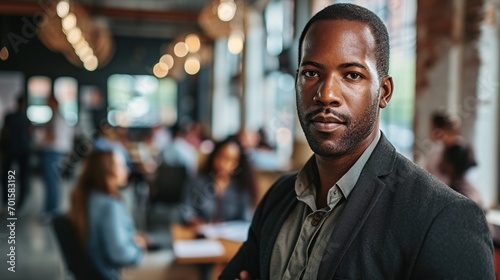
left=0, top=0, right=500, bottom=279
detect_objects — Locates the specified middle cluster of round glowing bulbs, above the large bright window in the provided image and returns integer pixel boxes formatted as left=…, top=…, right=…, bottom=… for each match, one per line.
left=153, top=34, right=201, bottom=78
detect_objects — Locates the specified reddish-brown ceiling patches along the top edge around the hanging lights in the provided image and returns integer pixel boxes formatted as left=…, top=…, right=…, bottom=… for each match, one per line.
left=0, top=0, right=269, bottom=39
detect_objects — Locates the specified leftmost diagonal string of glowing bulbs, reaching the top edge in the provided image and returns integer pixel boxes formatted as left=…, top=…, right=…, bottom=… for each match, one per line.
left=56, top=0, right=99, bottom=71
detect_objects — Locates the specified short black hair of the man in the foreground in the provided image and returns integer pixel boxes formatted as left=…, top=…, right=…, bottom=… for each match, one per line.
left=299, top=4, right=390, bottom=78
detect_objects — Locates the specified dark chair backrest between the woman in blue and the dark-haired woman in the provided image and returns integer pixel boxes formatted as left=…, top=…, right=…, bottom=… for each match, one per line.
left=150, top=164, right=188, bottom=203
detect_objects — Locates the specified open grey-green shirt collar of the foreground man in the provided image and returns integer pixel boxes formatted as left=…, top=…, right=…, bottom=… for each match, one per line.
left=295, top=130, right=381, bottom=210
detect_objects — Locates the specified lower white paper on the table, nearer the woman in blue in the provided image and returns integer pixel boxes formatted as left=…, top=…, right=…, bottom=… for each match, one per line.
left=174, top=239, right=225, bottom=258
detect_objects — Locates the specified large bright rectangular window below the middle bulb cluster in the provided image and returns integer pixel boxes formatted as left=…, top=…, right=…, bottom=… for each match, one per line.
left=108, top=74, right=177, bottom=127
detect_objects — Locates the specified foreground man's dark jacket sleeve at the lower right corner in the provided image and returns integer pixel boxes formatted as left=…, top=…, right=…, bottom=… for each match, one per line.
left=411, top=199, right=495, bottom=279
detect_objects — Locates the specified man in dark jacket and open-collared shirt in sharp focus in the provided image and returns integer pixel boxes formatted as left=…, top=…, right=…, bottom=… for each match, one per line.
left=220, top=4, right=494, bottom=280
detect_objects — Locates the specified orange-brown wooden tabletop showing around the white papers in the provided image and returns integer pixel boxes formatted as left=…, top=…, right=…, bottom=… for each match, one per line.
left=170, top=224, right=242, bottom=279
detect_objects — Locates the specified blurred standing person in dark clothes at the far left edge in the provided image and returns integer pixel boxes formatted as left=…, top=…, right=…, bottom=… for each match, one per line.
left=0, top=95, right=31, bottom=211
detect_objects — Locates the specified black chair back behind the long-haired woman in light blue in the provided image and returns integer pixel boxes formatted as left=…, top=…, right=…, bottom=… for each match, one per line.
left=52, top=215, right=106, bottom=280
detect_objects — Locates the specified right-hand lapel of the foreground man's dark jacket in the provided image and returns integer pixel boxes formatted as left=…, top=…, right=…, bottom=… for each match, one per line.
left=318, top=134, right=396, bottom=279
